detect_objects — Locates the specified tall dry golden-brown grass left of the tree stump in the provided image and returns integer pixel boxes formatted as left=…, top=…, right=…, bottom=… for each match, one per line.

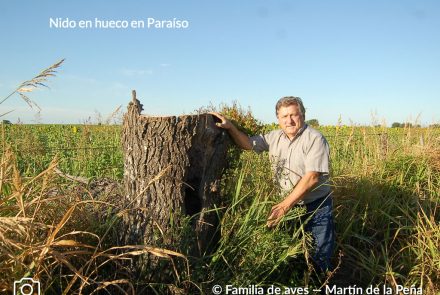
left=0, top=146, right=189, bottom=294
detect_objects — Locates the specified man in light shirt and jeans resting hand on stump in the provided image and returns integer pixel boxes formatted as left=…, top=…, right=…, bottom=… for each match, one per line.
left=211, top=96, right=335, bottom=272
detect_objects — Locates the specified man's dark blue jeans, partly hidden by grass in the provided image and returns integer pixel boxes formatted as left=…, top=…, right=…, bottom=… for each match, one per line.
left=304, top=194, right=335, bottom=272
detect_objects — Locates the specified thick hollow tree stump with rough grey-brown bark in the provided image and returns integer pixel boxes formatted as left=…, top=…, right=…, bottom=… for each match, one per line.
left=122, top=91, right=229, bottom=280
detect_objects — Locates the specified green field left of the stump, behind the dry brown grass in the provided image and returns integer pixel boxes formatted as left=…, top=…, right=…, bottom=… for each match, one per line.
left=3, top=124, right=123, bottom=179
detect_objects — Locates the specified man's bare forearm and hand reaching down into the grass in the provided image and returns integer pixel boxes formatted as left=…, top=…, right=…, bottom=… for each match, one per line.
left=266, top=171, right=320, bottom=227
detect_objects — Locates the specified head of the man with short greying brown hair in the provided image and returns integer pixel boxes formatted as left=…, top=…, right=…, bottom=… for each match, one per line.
left=275, top=96, right=306, bottom=139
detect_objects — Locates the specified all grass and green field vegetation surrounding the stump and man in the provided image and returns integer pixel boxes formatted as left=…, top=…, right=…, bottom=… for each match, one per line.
left=0, top=114, right=440, bottom=295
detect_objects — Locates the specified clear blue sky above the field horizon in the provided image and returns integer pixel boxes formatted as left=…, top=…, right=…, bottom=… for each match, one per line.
left=0, top=0, right=440, bottom=125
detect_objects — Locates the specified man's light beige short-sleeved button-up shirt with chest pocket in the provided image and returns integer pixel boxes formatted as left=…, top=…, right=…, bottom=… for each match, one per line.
left=251, top=124, right=330, bottom=204
